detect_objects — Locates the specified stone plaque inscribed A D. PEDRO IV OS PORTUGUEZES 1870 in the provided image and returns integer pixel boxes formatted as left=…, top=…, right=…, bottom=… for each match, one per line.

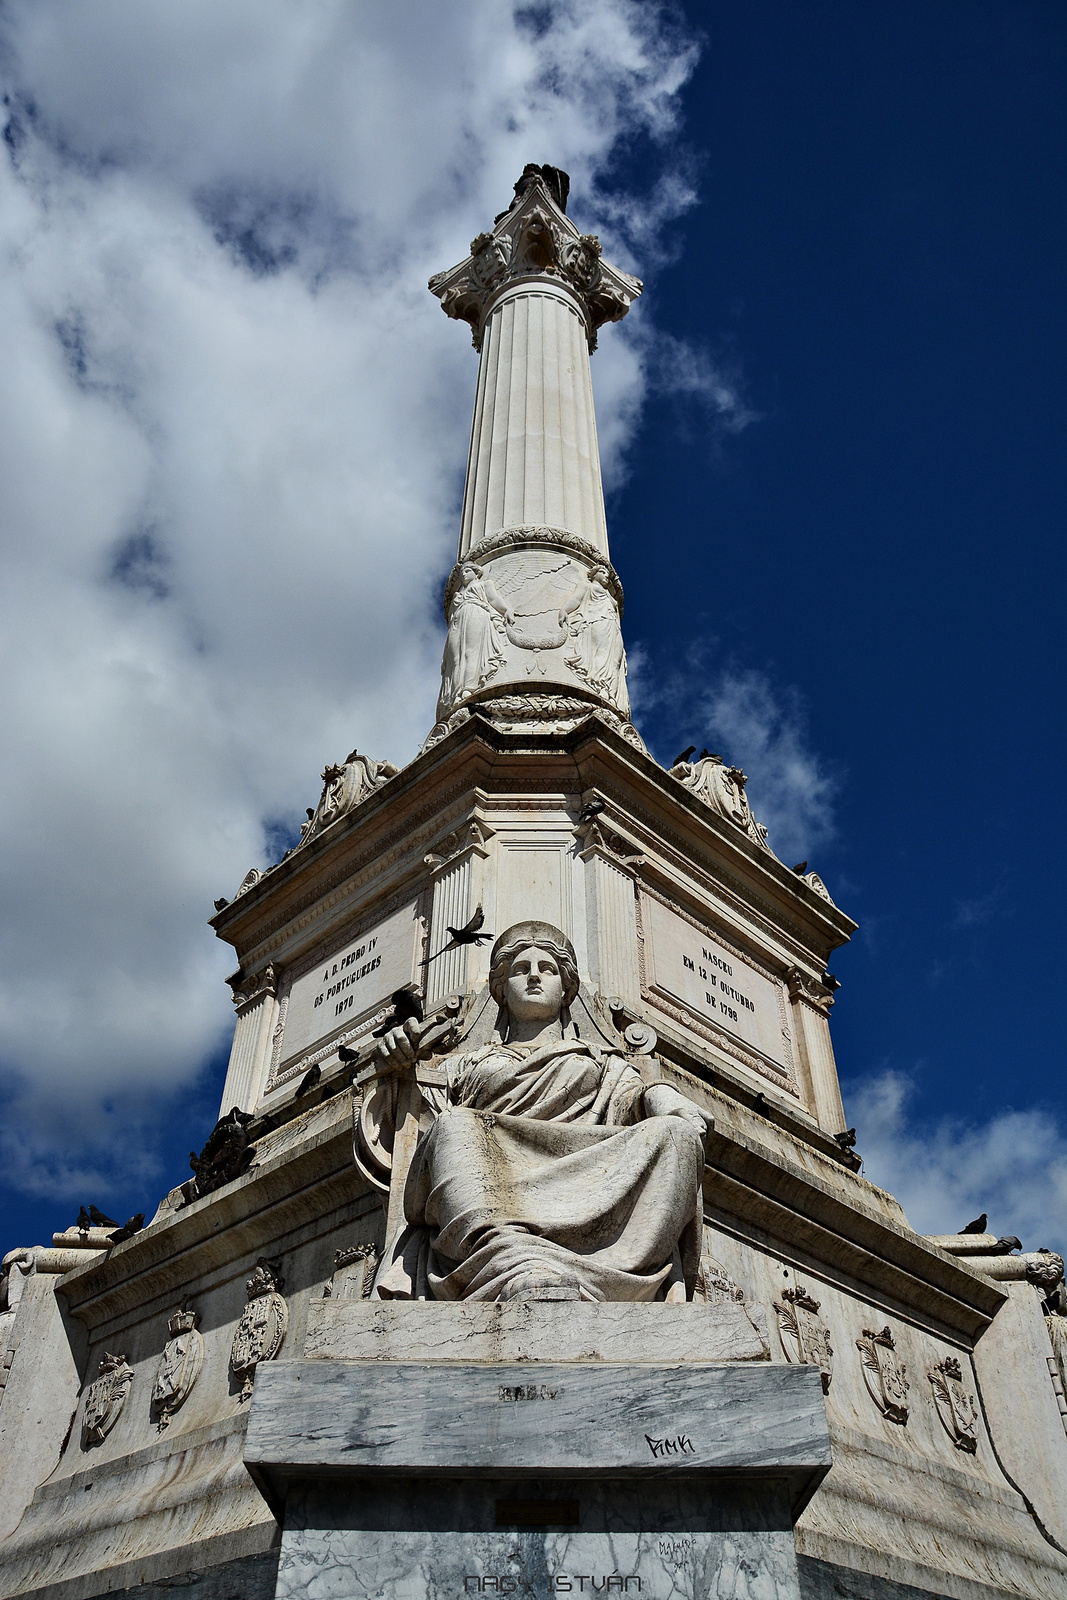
left=274, top=904, right=421, bottom=1080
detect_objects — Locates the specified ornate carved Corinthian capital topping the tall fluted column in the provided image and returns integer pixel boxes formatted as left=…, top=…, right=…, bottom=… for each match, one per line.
left=430, top=168, right=641, bottom=349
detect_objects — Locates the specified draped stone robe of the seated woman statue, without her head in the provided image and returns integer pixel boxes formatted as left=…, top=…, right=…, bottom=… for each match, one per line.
left=360, top=1038, right=704, bottom=1301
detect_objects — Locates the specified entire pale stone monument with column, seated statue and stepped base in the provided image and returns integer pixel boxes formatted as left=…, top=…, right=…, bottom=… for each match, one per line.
left=0, top=166, right=1067, bottom=1600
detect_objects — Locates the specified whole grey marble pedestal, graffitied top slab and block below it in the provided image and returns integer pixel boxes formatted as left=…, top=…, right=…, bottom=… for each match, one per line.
left=245, top=1356, right=830, bottom=1600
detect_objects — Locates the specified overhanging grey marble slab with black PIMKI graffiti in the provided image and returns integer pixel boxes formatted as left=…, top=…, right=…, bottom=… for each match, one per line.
left=245, top=1362, right=830, bottom=1501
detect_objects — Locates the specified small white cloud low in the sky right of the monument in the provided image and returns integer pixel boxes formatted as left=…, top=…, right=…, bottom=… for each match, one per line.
left=841, top=1070, right=1067, bottom=1253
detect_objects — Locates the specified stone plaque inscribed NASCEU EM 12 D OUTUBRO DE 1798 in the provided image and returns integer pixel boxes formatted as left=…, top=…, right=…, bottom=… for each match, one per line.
left=641, top=894, right=793, bottom=1082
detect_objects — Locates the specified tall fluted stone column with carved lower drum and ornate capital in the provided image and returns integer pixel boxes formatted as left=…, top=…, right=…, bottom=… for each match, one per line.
left=430, top=168, right=641, bottom=739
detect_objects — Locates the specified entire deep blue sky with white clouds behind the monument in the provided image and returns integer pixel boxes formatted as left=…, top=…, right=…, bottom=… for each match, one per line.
left=0, top=0, right=1067, bottom=1250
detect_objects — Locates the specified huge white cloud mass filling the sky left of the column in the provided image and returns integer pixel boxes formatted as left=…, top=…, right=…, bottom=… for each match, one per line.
left=0, top=0, right=694, bottom=1192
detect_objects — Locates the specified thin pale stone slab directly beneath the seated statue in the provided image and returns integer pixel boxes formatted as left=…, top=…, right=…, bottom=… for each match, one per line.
left=304, top=1299, right=769, bottom=1363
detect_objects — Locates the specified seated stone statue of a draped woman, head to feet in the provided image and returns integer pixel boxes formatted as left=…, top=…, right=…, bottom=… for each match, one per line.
left=357, top=922, right=709, bottom=1301
